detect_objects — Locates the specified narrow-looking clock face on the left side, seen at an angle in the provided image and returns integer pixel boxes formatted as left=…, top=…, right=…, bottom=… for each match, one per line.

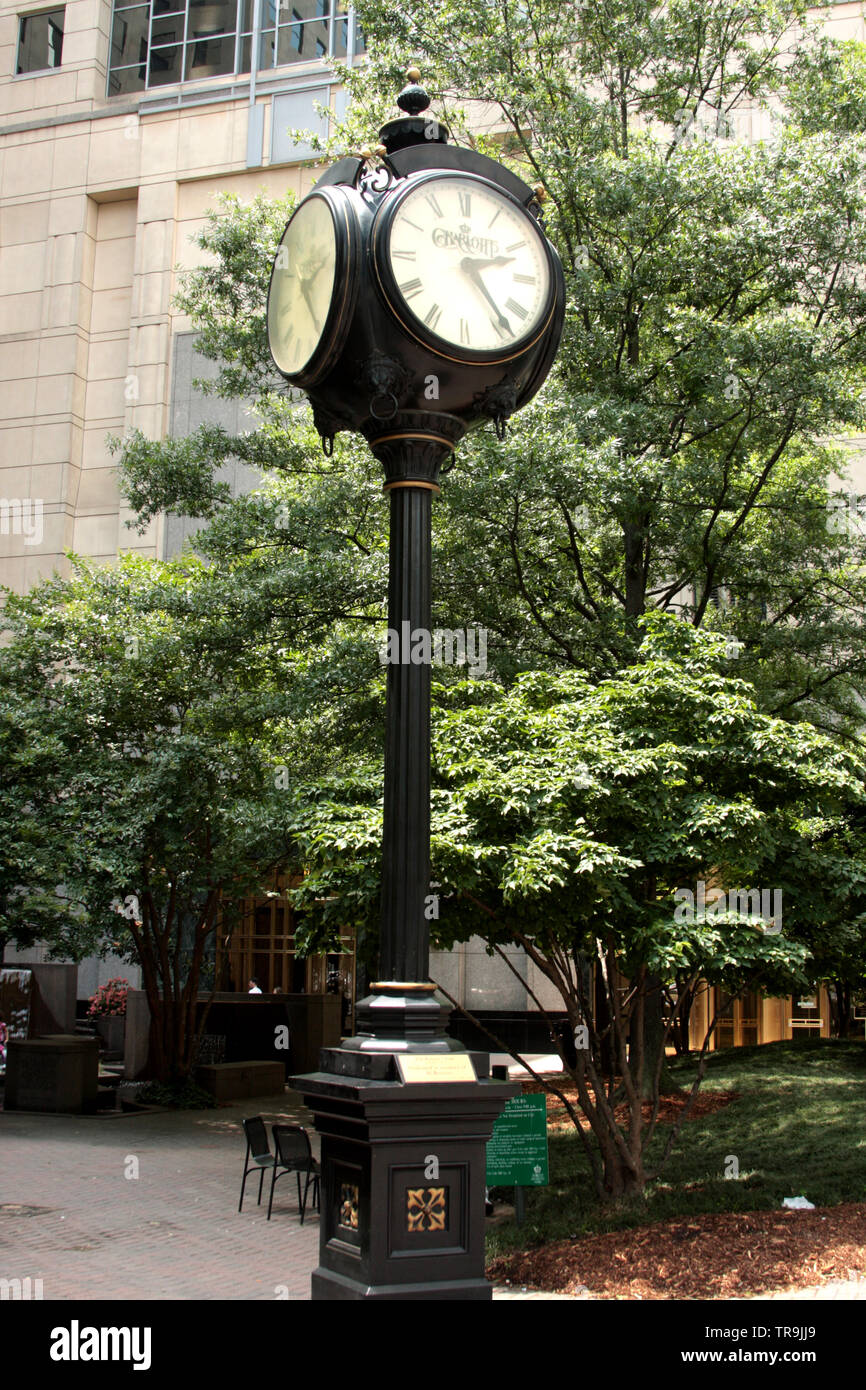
left=267, top=197, right=336, bottom=377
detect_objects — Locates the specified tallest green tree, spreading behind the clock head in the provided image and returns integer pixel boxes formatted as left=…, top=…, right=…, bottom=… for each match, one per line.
left=113, top=24, right=866, bottom=731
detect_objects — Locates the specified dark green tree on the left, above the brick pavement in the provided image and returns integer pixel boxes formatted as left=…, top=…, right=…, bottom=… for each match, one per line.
left=0, top=555, right=333, bottom=1080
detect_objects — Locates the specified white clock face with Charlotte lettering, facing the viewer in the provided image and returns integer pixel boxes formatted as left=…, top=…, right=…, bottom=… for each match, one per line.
left=384, top=175, right=550, bottom=357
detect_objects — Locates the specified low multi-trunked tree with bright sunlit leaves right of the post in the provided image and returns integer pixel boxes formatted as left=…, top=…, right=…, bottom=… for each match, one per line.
left=284, top=617, right=866, bottom=1198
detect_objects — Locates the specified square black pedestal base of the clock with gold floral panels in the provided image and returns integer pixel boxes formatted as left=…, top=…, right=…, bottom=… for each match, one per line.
left=292, top=981, right=517, bottom=1301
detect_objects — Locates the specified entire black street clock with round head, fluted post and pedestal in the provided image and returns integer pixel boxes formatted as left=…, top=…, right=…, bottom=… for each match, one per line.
left=268, top=68, right=564, bottom=1300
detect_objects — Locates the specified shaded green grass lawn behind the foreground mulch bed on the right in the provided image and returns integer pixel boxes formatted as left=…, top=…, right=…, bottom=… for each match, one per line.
left=488, top=1038, right=866, bottom=1257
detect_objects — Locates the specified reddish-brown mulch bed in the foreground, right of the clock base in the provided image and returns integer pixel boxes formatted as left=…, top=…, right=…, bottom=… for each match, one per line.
left=488, top=1202, right=866, bottom=1298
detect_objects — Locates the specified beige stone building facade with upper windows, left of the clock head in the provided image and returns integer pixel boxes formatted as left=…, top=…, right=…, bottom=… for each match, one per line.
left=0, top=0, right=363, bottom=591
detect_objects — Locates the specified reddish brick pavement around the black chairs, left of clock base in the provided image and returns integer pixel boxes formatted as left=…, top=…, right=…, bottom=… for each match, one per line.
left=0, top=1093, right=318, bottom=1300
